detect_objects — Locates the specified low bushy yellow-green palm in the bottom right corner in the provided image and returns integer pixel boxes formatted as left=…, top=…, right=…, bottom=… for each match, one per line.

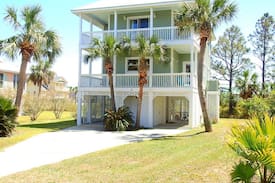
left=228, top=114, right=275, bottom=183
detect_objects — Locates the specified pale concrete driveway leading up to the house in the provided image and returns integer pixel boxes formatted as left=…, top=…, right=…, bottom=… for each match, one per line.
left=0, top=125, right=188, bottom=177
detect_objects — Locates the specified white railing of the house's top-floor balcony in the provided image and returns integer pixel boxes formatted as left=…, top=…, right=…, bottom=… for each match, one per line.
left=81, top=27, right=195, bottom=45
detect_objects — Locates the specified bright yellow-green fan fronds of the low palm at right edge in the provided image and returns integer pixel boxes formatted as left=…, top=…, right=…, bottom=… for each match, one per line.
left=228, top=114, right=275, bottom=182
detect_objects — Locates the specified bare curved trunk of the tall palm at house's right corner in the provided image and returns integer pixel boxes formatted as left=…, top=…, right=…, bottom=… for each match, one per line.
left=198, top=37, right=212, bottom=132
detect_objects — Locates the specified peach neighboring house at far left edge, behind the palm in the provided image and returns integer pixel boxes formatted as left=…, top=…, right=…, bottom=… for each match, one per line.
left=0, top=61, right=19, bottom=95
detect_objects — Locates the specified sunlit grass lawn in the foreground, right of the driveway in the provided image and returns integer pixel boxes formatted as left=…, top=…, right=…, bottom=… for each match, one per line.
left=0, top=119, right=242, bottom=183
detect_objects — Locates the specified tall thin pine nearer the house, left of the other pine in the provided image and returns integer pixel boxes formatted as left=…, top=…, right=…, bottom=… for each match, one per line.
left=212, top=26, right=251, bottom=116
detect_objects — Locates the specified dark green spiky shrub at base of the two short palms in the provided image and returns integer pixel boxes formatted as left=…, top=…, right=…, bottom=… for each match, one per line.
left=104, top=106, right=133, bottom=131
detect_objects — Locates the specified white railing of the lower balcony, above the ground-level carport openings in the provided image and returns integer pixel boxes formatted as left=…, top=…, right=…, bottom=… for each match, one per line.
left=80, top=73, right=193, bottom=88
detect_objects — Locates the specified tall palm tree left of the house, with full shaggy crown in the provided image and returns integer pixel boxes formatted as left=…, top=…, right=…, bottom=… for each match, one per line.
left=0, top=6, right=61, bottom=109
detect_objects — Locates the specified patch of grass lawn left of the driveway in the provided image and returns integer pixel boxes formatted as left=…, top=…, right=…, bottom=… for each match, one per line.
left=0, top=111, right=76, bottom=151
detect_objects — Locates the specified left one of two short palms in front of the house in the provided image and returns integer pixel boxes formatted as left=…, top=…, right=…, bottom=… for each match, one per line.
left=87, top=35, right=130, bottom=111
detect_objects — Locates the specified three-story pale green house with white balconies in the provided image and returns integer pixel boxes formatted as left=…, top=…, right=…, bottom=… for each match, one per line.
left=72, top=0, right=219, bottom=128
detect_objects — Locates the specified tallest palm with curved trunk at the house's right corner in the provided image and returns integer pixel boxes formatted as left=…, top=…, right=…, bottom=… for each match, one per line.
left=175, top=0, right=237, bottom=132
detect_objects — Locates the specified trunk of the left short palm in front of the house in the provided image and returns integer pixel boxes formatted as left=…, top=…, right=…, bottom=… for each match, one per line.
left=105, top=57, right=116, bottom=112
